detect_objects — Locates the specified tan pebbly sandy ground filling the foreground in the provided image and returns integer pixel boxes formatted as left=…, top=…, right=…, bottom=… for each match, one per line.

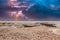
left=0, top=22, right=60, bottom=40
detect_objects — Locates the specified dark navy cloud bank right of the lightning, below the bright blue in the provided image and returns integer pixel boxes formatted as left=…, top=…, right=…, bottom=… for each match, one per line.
left=25, top=5, right=60, bottom=20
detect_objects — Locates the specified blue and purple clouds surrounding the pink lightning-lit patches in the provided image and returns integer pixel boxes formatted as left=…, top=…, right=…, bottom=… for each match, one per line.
left=0, top=0, right=60, bottom=21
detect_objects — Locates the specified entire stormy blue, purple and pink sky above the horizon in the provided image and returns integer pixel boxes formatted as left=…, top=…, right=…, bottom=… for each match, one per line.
left=0, top=0, right=60, bottom=21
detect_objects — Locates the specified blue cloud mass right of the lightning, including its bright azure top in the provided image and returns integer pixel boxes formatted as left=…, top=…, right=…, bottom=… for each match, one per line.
left=24, top=0, right=60, bottom=20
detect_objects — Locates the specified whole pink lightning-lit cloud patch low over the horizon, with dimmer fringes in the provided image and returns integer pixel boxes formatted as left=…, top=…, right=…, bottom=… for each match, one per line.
left=8, top=11, right=26, bottom=20
